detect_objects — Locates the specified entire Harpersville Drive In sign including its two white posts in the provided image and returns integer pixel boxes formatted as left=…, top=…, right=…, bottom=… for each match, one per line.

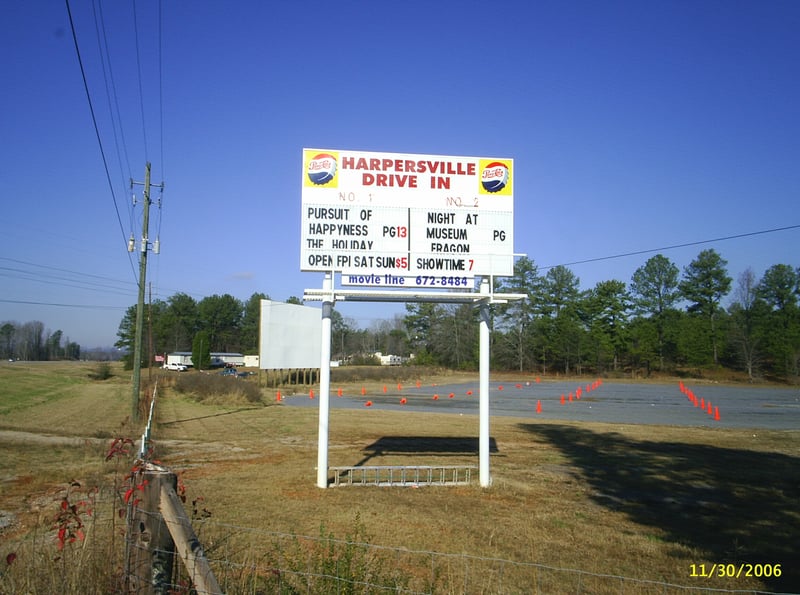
left=300, top=149, right=527, bottom=488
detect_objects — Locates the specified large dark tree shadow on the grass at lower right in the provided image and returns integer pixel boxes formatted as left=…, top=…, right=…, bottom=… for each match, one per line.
left=520, top=424, right=800, bottom=592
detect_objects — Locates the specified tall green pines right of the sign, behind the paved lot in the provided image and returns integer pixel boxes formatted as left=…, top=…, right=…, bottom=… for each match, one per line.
left=494, top=250, right=800, bottom=379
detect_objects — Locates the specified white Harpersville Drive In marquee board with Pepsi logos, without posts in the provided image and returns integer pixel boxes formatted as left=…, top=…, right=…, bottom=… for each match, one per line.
left=300, top=149, right=514, bottom=280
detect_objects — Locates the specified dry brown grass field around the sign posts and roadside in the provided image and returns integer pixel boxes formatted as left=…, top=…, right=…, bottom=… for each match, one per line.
left=0, top=360, right=800, bottom=593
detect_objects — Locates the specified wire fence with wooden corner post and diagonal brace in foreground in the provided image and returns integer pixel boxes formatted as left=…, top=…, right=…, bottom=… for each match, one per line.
left=0, top=385, right=788, bottom=595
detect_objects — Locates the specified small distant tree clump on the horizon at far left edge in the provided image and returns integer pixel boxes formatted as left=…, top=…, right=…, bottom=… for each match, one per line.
left=0, top=320, right=81, bottom=361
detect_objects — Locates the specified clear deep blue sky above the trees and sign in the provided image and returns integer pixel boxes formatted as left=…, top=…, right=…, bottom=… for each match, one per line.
left=0, top=0, right=800, bottom=349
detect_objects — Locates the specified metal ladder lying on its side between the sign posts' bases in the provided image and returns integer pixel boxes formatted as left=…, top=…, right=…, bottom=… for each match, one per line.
left=330, top=465, right=478, bottom=487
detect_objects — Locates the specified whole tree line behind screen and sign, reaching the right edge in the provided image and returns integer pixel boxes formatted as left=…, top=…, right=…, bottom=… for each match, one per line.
left=116, top=250, right=800, bottom=380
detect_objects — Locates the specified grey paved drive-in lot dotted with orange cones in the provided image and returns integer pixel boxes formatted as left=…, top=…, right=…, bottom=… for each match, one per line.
left=284, top=378, right=800, bottom=430
